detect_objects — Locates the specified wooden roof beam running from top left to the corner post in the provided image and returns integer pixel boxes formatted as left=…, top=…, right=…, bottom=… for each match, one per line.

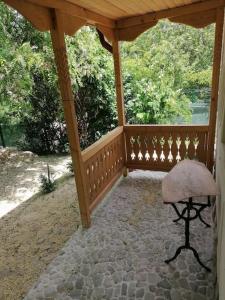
left=27, top=0, right=115, bottom=28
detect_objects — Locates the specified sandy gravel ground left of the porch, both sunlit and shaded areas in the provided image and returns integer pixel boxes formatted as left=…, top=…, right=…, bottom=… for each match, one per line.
left=0, top=152, right=80, bottom=300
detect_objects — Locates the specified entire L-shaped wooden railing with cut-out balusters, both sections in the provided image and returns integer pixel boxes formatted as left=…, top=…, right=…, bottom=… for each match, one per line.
left=82, top=125, right=209, bottom=216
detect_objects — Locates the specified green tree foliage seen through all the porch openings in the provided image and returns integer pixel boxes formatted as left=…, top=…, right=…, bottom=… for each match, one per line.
left=0, top=3, right=214, bottom=153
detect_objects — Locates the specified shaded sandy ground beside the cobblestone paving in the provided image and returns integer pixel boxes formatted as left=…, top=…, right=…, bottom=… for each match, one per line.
left=0, top=162, right=80, bottom=300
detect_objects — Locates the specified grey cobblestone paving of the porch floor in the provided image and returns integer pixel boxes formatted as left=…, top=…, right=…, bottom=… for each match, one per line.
left=25, top=171, right=215, bottom=300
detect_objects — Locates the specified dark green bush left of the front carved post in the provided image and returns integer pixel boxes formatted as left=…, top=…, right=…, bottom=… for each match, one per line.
left=20, top=72, right=68, bottom=154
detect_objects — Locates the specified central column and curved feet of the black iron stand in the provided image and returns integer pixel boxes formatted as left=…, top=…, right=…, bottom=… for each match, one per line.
left=165, top=197, right=211, bottom=272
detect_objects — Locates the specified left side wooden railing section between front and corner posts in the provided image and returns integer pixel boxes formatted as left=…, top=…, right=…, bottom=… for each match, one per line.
left=82, top=126, right=125, bottom=211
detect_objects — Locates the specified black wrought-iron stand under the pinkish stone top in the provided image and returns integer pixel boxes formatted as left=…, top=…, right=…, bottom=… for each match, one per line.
left=165, top=197, right=211, bottom=272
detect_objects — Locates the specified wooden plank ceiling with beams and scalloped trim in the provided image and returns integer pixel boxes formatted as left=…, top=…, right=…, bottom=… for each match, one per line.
left=4, top=0, right=225, bottom=41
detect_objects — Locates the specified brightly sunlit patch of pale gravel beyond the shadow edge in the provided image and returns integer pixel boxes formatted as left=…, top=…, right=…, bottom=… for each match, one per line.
left=0, top=151, right=70, bottom=218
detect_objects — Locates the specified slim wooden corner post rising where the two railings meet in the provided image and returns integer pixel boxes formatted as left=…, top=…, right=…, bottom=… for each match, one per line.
left=112, top=40, right=125, bottom=126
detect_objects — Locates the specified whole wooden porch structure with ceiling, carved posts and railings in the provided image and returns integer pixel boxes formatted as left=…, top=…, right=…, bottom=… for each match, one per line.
left=4, top=0, right=225, bottom=227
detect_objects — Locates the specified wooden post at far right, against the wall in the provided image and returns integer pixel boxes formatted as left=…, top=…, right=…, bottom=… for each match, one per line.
left=207, top=8, right=224, bottom=171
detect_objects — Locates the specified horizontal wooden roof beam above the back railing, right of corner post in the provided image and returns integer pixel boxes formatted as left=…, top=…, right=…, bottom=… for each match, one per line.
left=116, top=0, right=225, bottom=28
